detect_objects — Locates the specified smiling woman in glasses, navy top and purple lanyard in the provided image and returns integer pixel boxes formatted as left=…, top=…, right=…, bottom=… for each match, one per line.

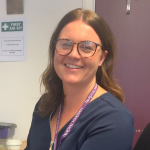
left=25, top=9, right=134, bottom=150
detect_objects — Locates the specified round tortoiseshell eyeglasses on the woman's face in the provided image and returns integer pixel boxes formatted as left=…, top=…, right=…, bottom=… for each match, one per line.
left=55, top=39, right=102, bottom=57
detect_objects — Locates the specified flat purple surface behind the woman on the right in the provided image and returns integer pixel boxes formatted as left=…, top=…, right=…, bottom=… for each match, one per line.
left=96, top=0, right=150, bottom=148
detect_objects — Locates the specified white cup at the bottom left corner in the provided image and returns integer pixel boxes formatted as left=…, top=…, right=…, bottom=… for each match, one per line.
left=6, top=140, right=22, bottom=150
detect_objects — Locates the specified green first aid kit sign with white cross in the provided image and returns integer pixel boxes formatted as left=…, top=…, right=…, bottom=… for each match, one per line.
left=1, top=21, right=23, bottom=32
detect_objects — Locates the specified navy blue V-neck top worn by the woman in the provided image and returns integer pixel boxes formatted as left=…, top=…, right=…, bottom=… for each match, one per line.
left=25, top=92, right=134, bottom=150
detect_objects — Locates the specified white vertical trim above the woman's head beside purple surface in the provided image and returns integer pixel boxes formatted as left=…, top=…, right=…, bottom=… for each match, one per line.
left=82, top=0, right=95, bottom=12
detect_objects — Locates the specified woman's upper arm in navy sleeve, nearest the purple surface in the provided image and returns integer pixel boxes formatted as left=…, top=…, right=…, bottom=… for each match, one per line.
left=80, top=109, right=134, bottom=150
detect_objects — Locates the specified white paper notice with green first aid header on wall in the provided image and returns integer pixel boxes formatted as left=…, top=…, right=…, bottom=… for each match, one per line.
left=0, top=18, right=27, bottom=61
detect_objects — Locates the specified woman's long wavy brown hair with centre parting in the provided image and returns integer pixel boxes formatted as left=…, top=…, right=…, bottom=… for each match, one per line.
left=39, top=8, right=124, bottom=117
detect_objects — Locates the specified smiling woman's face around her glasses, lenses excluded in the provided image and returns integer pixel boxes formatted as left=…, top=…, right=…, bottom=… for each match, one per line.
left=54, top=20, right=107, bottom=85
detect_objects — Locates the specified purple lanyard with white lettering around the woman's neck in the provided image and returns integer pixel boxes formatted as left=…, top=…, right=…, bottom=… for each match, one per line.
left=54, top=83, right=98, bottom=150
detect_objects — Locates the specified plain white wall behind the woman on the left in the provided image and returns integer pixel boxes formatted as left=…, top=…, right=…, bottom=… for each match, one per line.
left=0, top=0, right=82, bottom=140
